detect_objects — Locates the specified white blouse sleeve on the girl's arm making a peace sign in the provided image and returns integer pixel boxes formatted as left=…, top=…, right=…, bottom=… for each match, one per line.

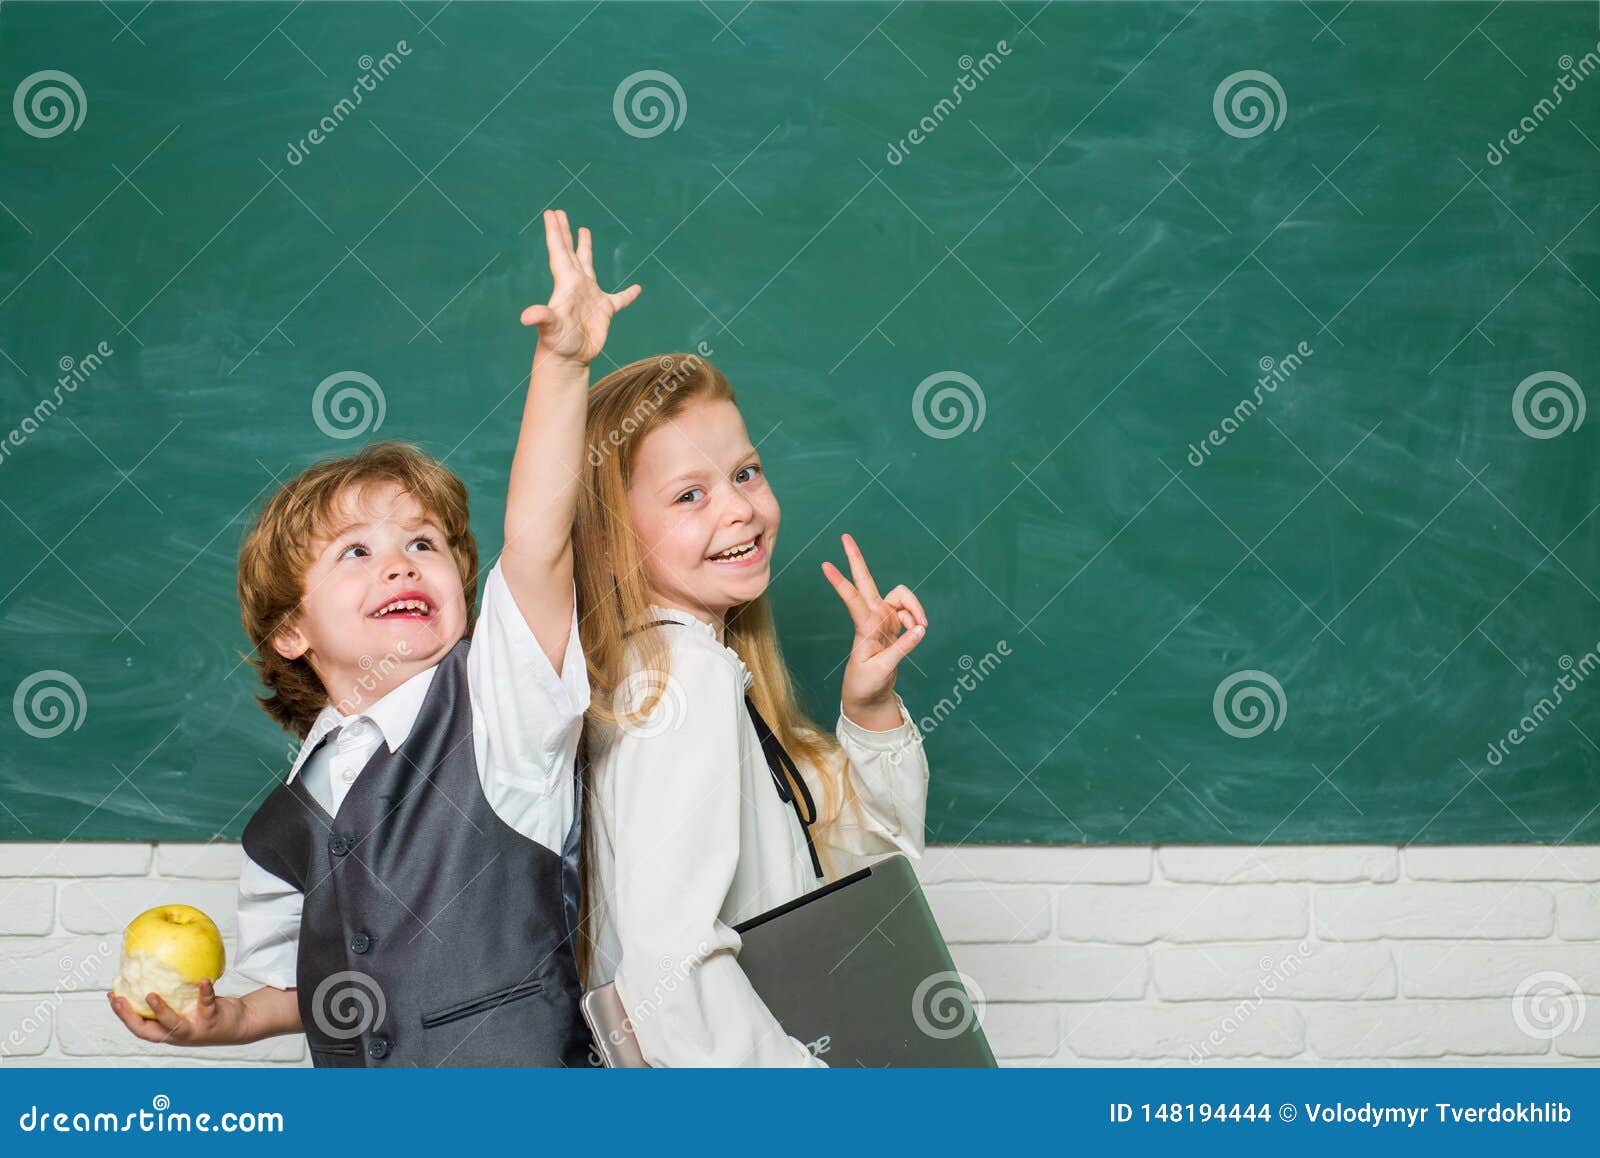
left=806, top=696, right=928, bottom=878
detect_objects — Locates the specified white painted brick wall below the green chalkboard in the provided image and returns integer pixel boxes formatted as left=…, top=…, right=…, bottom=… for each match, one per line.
left=0, top=843, right=1600, bottom=1065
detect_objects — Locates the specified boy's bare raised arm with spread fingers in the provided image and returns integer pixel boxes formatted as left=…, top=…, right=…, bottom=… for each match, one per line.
left=501, top=210, right=640, bottom=673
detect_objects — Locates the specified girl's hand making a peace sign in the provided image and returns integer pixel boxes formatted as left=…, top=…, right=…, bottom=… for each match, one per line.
left=822, top=534, right=928, bottom=731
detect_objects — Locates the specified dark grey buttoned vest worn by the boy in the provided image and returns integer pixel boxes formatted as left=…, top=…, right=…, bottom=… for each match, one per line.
left=233, top=640, right=592, bottom=1067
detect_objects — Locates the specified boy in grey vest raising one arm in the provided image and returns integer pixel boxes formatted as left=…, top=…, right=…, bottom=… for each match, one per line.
left=109, top=211, right=638, bottom=1067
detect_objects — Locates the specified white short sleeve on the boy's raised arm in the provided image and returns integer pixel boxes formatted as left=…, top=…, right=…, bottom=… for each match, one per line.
left=467, top=563, right=589, bottom=853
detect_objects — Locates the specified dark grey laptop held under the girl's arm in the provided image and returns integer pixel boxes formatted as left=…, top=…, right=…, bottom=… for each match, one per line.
left=582, top=854, right=995, bottom=1067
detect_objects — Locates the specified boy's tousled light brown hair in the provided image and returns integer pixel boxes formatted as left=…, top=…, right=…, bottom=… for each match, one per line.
left=238, top=441, right=478, bottom=737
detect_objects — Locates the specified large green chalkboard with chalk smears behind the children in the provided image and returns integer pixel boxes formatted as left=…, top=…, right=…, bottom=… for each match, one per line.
left=0, top=2, right=1600, bottom=843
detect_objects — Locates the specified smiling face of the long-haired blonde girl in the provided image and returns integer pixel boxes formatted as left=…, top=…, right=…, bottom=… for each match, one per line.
left=627, top=400, right=779, bottom=625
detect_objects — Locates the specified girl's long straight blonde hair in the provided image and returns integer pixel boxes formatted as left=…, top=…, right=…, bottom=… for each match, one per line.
left=573, top=353, right=846, bottom=974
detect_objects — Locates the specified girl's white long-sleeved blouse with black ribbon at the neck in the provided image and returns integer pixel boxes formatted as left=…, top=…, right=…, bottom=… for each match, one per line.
left=586, top=606, right=928, bottom=1067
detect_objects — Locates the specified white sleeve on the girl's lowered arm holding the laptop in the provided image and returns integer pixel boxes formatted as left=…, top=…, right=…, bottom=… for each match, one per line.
left=610, top=648, right=826, bottom=1067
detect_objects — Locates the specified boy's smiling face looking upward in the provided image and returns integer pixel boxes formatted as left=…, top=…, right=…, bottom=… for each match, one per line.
left=274, top=483, right=467, bottom=715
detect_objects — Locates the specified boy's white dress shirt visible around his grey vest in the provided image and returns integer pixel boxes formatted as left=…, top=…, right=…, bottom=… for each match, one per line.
left=234, top=563, right=589, bottom=988
